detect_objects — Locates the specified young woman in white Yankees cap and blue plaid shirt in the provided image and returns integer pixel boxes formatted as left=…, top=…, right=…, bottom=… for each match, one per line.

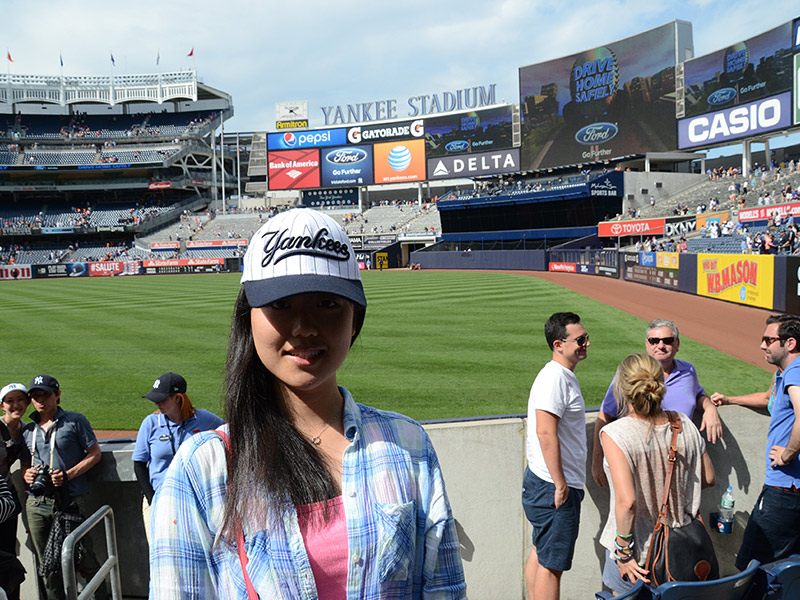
left=150, top=209, right=466, bottom=600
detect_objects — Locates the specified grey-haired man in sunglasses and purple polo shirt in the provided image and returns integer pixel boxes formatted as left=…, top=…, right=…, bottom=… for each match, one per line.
left=592, top=319, right=722, bottom=487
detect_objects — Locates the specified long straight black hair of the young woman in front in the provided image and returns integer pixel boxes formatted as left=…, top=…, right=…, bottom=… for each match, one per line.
left=222, top=289, right=366, bottom=539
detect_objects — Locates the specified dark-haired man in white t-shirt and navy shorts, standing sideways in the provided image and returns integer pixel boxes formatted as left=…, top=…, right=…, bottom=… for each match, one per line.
left=522, top=313, right=589, bottom=600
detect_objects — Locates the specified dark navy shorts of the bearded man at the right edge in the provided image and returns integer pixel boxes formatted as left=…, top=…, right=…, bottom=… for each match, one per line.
left=736, top=485, right=800, bottom=571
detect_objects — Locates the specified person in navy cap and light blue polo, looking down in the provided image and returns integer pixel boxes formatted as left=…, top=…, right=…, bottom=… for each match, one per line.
left=133, top=373, right=224, bottom=542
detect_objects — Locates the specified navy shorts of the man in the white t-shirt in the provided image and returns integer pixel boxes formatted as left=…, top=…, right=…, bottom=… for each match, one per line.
left=522, top=469, right=584, bottom=571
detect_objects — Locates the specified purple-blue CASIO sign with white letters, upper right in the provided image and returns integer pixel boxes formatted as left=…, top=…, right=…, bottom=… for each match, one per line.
left=678, top=92, right=792, bottom=150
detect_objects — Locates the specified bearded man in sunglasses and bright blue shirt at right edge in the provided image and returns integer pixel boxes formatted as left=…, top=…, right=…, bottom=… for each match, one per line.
left=736, top=315, right=800, bottom=570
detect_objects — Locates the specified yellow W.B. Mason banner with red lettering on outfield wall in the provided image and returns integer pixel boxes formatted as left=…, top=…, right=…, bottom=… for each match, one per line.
left=697, top=254, right=775, bottom=309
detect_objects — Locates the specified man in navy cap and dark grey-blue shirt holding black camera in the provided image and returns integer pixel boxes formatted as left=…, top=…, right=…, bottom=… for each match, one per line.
left=21, top=375, right=105, bottom=600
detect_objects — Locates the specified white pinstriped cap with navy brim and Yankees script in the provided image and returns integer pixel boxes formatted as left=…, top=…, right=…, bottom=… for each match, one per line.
left=242, top=208, right=367, bottom=308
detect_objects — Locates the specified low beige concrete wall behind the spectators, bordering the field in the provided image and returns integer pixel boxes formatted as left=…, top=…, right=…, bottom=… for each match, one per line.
left=10, top=406, right=769, bottom=600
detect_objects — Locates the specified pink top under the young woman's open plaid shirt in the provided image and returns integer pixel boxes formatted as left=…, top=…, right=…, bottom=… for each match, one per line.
left=296, top=496, right=347, bottom=600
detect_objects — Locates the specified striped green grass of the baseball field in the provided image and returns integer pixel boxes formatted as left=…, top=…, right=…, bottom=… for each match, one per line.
left=0, top=271, right=769, bottom=430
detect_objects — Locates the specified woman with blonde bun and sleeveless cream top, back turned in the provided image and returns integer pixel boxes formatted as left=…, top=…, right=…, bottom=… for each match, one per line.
left=600, top=354, right=714, bottom=594
